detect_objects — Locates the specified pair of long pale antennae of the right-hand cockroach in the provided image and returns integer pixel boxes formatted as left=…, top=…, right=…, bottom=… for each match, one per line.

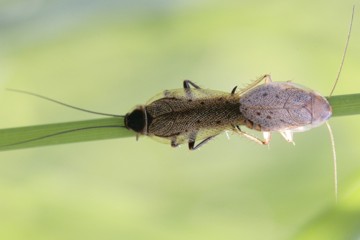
left=325, top=5, right=355, bottom=202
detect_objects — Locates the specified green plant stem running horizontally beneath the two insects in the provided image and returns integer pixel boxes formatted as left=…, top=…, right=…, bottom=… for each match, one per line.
left=0, top=94, right=360, bottom=151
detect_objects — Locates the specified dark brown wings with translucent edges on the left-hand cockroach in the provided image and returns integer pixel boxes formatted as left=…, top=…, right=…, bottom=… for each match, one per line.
left=146, top=92, right=242, bottom=148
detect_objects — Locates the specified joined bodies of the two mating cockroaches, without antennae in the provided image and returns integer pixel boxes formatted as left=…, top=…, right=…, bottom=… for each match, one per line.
left=125, top=75, right=331, bottom=150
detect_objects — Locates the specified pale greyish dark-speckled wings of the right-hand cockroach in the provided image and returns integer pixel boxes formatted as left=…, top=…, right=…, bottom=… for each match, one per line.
left=240, top=82, right=312, bottom=131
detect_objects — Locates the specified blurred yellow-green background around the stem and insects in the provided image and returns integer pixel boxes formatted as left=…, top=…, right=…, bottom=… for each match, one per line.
left=0, top=0, right=360, bottom=240
